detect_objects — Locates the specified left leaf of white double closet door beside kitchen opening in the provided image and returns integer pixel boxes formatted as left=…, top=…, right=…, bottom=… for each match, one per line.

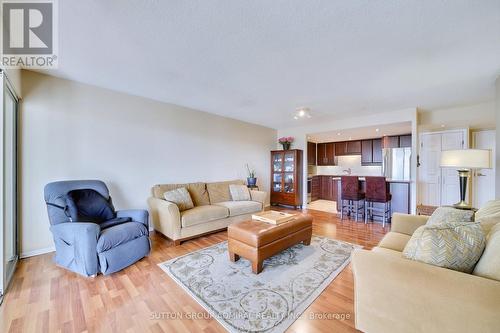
left=419, top=133, right=441, bottom=206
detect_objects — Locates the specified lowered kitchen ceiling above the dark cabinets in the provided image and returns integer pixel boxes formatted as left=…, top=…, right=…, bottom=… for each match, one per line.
left=307, top=122, right=411, bottom=142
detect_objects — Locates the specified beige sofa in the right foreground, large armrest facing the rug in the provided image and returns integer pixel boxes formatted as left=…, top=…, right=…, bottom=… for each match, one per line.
left=352, top=214, right=500, bottom=333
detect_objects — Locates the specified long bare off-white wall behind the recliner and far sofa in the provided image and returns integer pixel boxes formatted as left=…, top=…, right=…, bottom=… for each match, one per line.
left=20, top=71, right=276, bottom=255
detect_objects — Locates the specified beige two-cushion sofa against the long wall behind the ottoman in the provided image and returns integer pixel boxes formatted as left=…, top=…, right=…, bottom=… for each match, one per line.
left=148, top=180, right=267, bottom=245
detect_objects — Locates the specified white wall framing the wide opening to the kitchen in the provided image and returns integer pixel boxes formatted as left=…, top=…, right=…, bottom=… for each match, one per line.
left=277, top=108, right=417, bottom=212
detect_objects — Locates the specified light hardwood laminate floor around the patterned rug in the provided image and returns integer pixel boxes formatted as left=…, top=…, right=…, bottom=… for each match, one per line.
left=0, top=210, right=390, bottom=333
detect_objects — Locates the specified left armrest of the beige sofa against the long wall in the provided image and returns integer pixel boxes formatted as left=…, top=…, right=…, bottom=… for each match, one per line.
left=148, top=197, right=181, bottom=240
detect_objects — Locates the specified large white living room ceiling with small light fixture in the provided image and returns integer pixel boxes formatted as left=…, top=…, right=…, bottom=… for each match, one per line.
left=38, top=0, right=500, bottom=128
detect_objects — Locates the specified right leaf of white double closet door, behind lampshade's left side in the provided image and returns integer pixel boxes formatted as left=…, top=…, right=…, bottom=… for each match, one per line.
left=441, top=131, right=468, bottom=206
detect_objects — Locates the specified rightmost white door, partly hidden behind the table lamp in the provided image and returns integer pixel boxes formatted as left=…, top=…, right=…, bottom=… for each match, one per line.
left=472, top=130, right=496, bottom=208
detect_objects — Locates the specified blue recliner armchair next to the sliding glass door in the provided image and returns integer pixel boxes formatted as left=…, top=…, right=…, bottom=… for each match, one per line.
left=44, top=180, right=151, bottom=276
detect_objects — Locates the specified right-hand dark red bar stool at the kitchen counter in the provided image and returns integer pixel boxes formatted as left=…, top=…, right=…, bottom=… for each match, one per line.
left=365, top=177, right=392, bottom=227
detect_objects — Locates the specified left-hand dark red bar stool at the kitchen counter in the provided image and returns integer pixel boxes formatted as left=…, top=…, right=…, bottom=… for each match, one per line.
left=340, top=176, right=365, bottom=222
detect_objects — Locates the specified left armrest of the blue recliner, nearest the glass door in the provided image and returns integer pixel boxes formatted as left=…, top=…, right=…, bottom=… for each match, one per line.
left=50, top=222, right=101, bottom=276
